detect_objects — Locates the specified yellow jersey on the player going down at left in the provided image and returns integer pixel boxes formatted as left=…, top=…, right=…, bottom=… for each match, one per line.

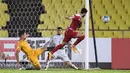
left=17, top=40, right=33, bottom=56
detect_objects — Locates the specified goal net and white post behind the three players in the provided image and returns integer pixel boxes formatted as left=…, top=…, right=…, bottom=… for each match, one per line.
left=0, top=0, right=89, bottom=69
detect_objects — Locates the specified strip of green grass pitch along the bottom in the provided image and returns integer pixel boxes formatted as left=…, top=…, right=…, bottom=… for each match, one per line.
left=0, top=69, right=130, bottom=73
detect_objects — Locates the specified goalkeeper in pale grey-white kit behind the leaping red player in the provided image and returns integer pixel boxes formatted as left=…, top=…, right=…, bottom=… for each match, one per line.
left=44, top=27, right=78, bottom=70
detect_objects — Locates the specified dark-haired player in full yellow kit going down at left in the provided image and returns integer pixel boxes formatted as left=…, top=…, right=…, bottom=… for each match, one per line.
left=16, top=31, right=47, bottom=70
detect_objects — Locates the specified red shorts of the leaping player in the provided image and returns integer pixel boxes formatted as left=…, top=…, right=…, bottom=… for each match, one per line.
left=63, top=28, right=79, bottom=42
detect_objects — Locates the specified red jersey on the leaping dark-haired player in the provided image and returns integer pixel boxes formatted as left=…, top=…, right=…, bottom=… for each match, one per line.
left=69, top=14, right=82, bottom=30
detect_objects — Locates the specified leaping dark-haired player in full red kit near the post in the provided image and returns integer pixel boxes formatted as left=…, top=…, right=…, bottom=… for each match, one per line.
left=48, top=8, right=88, bottom=60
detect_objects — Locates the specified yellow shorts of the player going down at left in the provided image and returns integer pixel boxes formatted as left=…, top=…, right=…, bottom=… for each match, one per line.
left=28, top=48, right=41, bottom=68
